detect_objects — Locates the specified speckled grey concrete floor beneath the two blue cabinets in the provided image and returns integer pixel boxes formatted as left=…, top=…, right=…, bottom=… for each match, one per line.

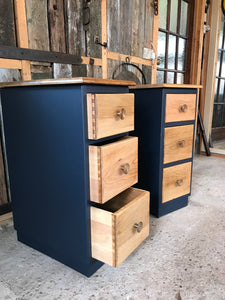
left=0, top=156, right=225, bottom=300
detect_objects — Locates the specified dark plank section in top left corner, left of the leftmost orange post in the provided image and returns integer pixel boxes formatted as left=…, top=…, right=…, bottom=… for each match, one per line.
left=0, top=0, right=16, bottom=46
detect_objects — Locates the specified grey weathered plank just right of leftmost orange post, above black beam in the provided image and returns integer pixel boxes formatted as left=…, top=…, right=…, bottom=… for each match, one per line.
left=26, top=0, right=49, bottom=51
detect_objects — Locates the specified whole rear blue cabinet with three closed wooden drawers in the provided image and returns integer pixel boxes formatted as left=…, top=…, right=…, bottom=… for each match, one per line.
left=131, top=84, right=198, bottom=217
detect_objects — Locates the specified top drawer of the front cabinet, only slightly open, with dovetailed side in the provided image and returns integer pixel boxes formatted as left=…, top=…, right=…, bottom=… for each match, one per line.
left=87, top=94, right=134, bottom=140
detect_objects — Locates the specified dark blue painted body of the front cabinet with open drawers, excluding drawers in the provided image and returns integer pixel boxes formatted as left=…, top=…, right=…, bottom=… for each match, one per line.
left=1, top=85, right=128, bottom=276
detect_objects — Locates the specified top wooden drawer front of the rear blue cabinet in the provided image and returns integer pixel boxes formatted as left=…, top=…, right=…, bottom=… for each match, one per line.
left=165, top=94, right=196, bottom=123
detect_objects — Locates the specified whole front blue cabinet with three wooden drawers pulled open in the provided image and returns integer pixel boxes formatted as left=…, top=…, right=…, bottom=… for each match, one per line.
left=0, top=78, right=149, bottom=276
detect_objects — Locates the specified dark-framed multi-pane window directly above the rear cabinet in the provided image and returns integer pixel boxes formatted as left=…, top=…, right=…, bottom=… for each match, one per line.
left=157, top=0, right=191, bottom=83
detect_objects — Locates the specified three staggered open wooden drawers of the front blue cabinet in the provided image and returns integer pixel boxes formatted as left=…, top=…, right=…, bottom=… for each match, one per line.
left=87, top=94, right=149, bottom=267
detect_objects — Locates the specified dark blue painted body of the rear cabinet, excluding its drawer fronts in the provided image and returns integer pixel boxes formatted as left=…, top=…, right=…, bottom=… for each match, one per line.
left=130, top=88, right=197, bottom=217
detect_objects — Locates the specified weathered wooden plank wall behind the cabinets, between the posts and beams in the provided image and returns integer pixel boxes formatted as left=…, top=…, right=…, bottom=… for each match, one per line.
left=0, top=0, right=153, bottom=83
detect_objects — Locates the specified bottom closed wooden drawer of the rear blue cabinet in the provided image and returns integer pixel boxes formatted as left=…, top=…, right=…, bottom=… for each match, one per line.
left=162, top=162, right=191, bottom=203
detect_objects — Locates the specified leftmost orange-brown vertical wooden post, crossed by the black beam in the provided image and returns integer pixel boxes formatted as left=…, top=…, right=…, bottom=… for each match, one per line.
left=14, top=0, right=31, bottom=80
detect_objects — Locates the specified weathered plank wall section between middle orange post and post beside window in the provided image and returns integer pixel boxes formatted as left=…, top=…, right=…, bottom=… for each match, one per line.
left=107, top=0, right=153, bottom=83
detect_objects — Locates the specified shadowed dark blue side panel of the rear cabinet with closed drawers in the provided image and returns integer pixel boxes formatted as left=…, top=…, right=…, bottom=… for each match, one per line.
left=130, top=89, right=164, bottom=215
